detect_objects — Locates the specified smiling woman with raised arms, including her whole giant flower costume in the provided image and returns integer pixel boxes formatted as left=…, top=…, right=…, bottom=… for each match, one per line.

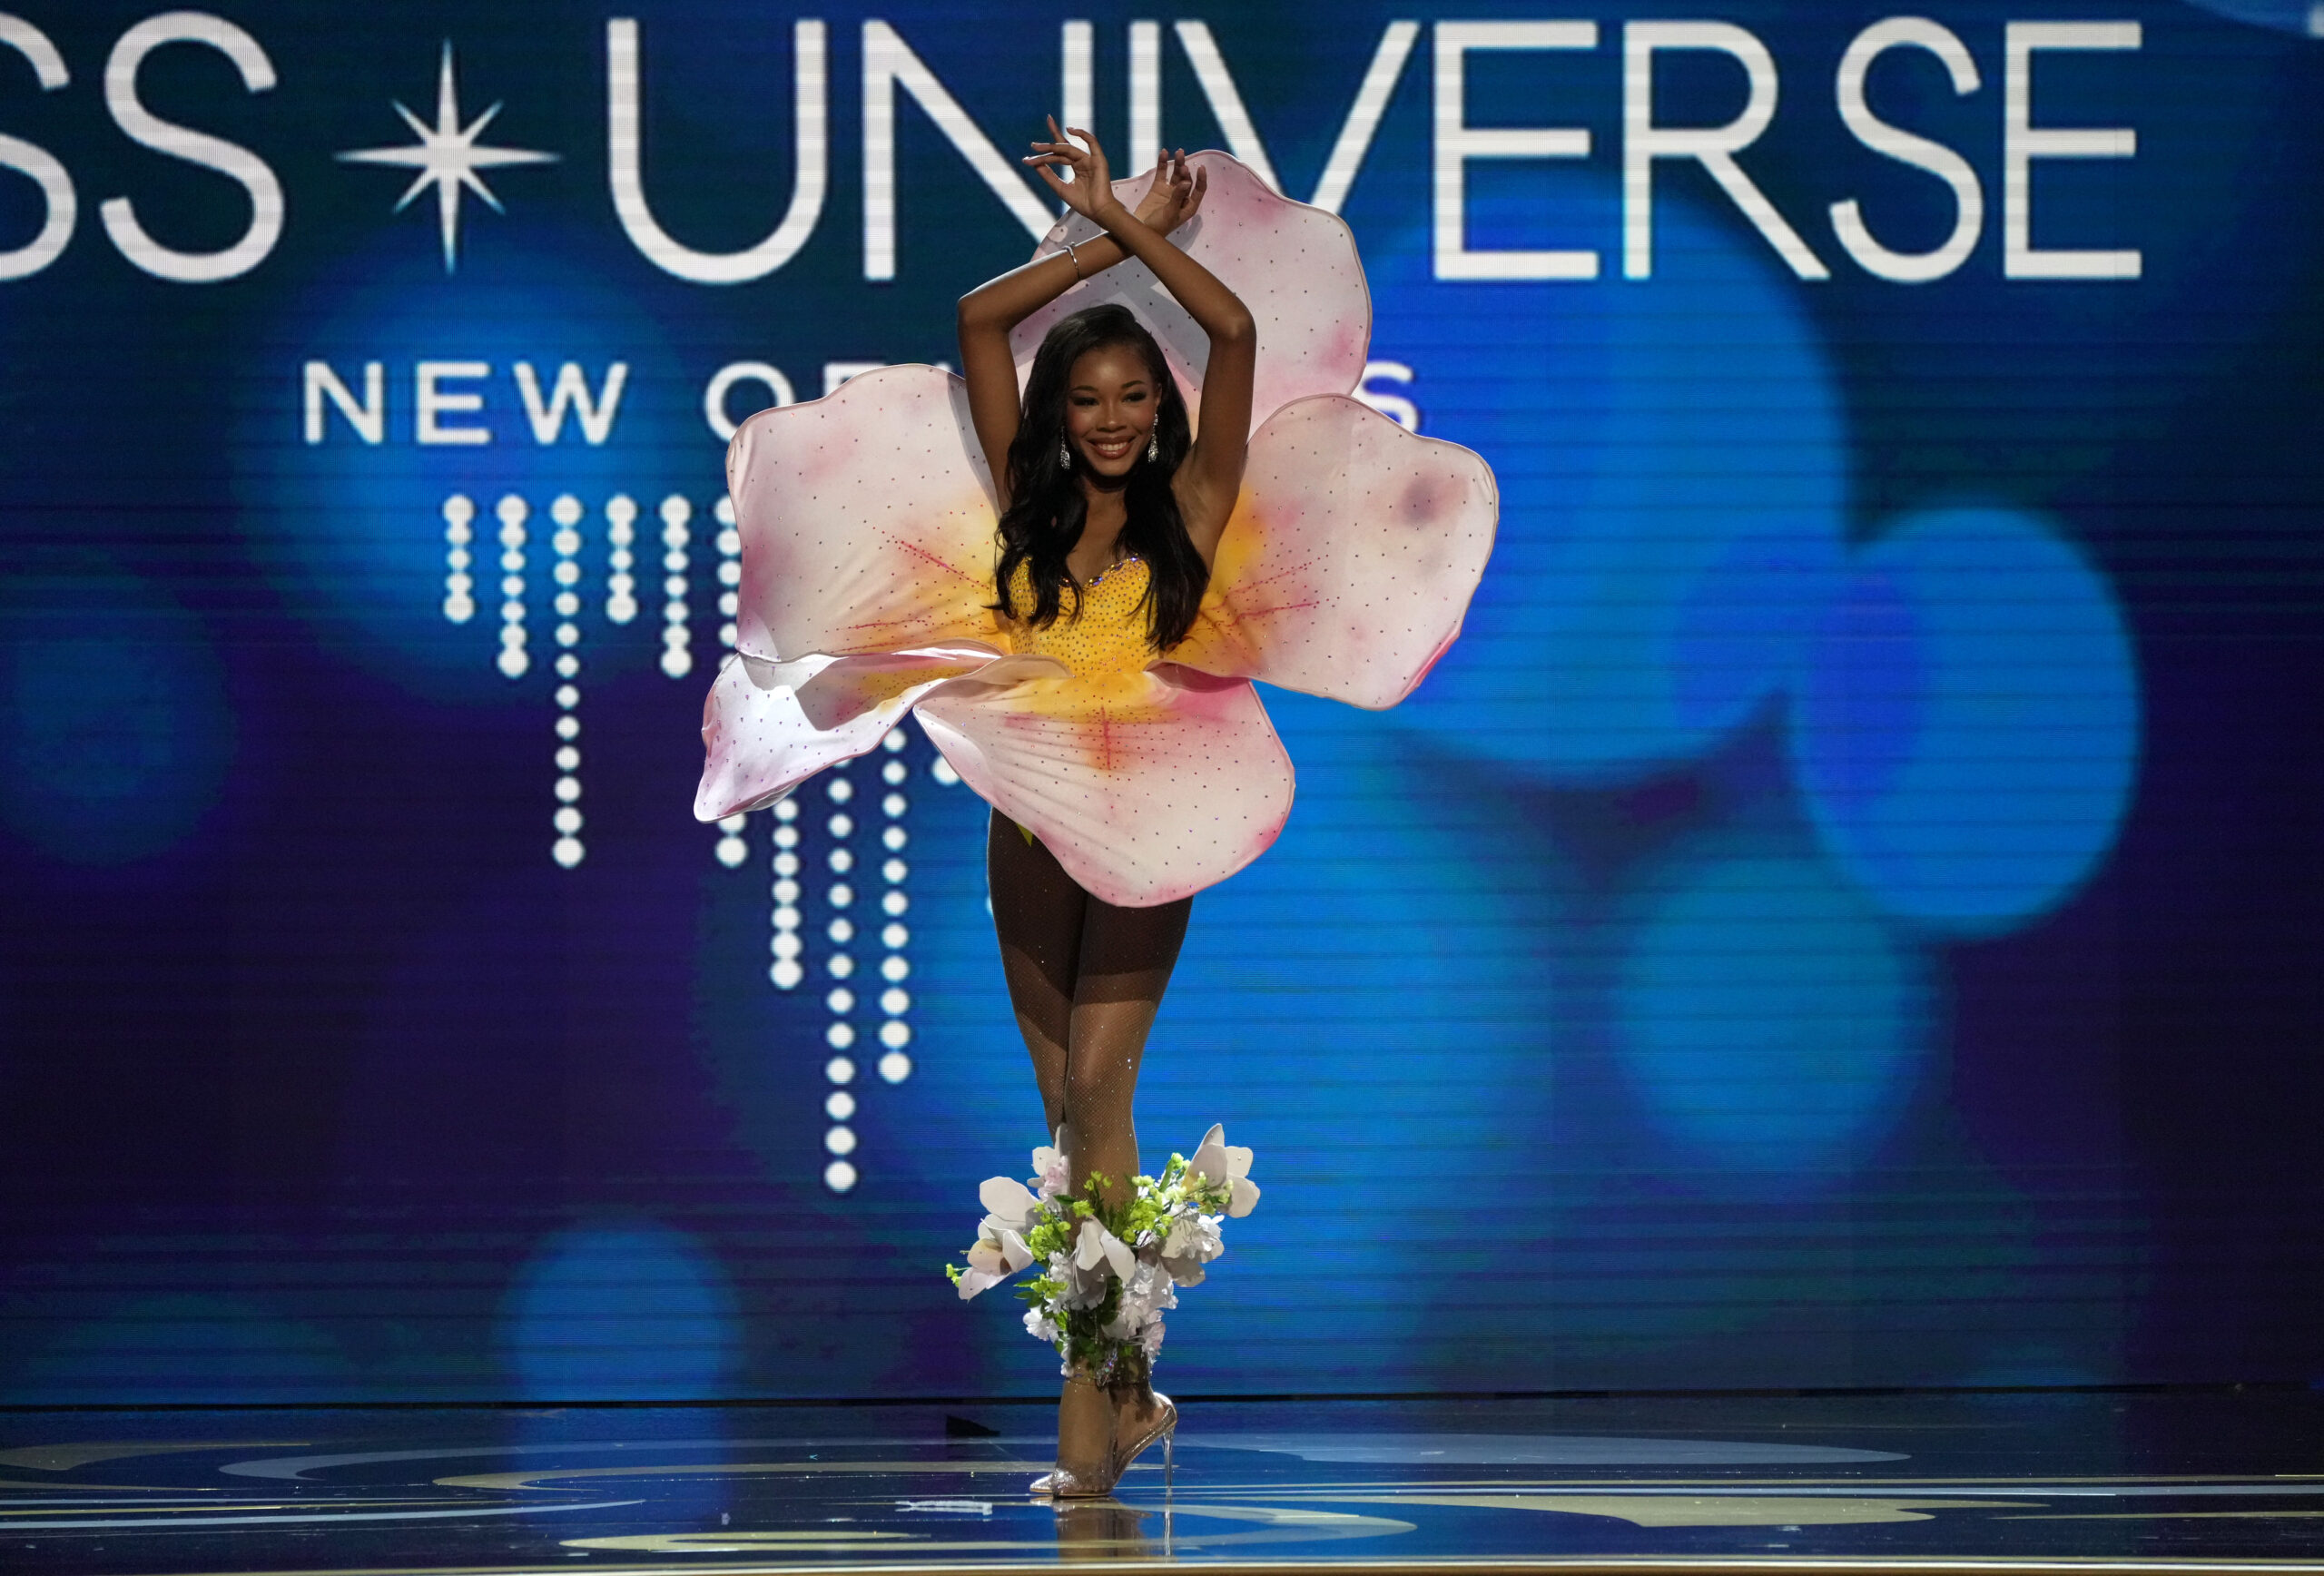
left=694, top=121, right=1497, bottom=1500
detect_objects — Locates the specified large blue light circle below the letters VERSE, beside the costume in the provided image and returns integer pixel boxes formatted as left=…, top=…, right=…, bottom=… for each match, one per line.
left=1376, top=172, right=1847, bottom=785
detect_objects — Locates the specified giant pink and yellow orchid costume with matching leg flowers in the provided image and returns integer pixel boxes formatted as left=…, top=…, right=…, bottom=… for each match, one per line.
left=694, top=153, right=1497, bottom=1404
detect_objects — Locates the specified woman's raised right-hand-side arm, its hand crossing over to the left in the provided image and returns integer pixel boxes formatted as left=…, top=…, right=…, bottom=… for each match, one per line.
left=1025, top=121, right=1260, bottom=563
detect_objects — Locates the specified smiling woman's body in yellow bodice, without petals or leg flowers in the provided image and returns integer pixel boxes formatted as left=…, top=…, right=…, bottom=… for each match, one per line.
left=960, top=121, right=1257, bottom=1494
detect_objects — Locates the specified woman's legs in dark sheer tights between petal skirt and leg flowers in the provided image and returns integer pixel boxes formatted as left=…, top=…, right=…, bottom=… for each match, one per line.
left=985, top=813, right=1195, bottom=1202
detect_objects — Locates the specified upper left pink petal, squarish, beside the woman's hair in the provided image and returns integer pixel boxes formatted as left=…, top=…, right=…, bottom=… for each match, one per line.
left=727, top=368, right=1006, bottom=658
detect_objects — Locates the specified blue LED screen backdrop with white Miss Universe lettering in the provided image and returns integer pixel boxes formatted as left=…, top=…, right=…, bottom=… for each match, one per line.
left=0, top=0, right=2324, bottom=1402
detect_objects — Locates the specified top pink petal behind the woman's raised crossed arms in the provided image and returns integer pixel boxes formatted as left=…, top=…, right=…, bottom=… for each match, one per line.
left=1009, top=151, right=1371, bottom=438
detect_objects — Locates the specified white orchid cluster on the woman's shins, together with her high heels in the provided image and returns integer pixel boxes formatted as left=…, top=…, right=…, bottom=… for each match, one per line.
left=946, top=1125, right=1260, bottom=1497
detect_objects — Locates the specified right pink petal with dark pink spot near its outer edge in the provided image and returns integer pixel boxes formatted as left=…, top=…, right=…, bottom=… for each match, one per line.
left=1171, top=398, right=1499, bottom=709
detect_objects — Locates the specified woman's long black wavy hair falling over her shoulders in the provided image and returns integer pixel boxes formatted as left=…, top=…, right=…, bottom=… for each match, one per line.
left=992, top=304, right=1211, bottom=651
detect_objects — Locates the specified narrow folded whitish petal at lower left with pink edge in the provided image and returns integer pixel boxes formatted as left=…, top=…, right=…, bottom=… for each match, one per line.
left=694, top=646, right=1016, bottom=821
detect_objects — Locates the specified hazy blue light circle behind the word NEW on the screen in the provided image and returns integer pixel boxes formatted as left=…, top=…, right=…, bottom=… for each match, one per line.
left=235, top=232, right=683, bottom=704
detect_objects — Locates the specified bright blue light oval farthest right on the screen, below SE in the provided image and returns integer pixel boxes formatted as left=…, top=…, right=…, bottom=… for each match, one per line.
left=1789, top=509, right=2141, bottom=934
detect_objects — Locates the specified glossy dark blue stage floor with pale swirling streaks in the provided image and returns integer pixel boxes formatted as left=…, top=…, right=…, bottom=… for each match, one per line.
left=0, top=1390, right=2324, bottom=1576
